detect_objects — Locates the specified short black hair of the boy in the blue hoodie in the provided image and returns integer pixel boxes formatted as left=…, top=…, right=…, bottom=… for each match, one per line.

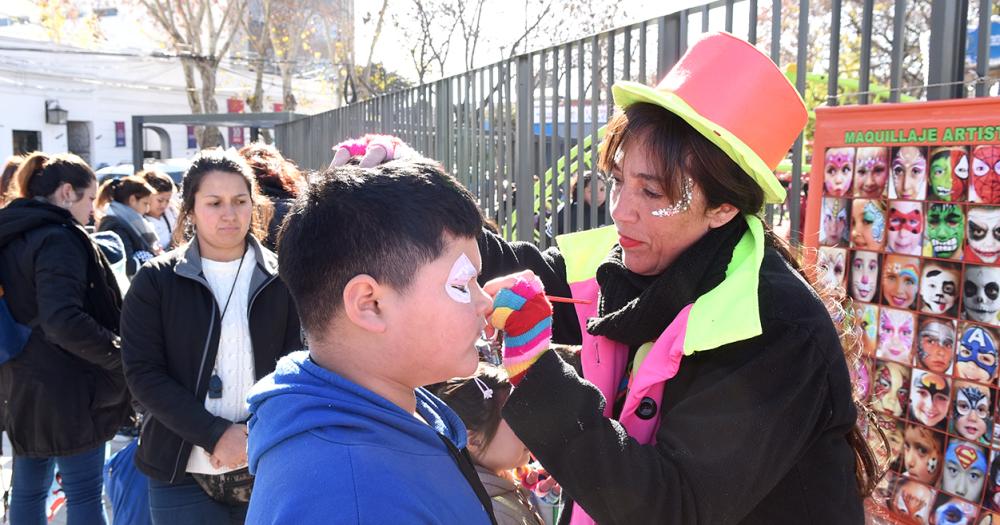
left=278, top=159, right=483, bottom=334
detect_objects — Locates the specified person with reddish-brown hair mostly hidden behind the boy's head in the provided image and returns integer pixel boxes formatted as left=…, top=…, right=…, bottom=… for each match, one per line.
left=240, top=142, right=305, bottom=250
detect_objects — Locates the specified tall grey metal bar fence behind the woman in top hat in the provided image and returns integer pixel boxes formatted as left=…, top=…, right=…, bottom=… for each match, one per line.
left=276, top=0, right=996, bottom=247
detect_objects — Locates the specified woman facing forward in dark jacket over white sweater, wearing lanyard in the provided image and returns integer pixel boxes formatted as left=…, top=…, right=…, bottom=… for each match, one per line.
left=122, top=150, right=301, bottom=524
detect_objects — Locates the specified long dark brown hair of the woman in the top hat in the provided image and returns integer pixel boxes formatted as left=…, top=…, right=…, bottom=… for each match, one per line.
left=598, top=103, right=888, bottom=497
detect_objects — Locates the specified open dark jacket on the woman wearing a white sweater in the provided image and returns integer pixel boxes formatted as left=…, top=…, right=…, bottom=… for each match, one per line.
left=122, top=237, right=302, bottom=483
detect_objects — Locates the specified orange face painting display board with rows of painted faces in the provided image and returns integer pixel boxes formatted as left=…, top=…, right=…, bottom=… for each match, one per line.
left=805, top=98, right=1000, bottom=524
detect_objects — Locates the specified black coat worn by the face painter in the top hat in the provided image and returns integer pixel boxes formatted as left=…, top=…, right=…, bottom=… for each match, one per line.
left=480, top=229, right=863, bottom=524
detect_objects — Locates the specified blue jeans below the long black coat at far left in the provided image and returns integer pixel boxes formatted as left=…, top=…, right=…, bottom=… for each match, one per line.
left=10, top=445, right=108, bottom=525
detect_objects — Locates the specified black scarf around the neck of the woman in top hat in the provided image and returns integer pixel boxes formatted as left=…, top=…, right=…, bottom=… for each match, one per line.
left=587, top=216, right=747, bottom=347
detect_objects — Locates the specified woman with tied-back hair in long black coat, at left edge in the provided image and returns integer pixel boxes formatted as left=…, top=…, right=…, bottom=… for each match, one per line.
left=0, top=153, right=131, bottom=524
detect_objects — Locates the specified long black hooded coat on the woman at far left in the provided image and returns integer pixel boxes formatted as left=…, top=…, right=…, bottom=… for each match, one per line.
left=0, top=199, right=131, bottom=457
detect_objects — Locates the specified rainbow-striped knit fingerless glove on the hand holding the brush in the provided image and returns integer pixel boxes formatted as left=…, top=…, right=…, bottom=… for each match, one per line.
left=490, top=276, right=552, bottom=385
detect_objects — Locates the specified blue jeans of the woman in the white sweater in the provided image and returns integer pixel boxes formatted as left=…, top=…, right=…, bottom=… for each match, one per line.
left=149, top=474, right=249, bottom=525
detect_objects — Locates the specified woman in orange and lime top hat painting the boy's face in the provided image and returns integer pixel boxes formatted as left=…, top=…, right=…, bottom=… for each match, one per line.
left=472, top=33, right=877, bottom=525
